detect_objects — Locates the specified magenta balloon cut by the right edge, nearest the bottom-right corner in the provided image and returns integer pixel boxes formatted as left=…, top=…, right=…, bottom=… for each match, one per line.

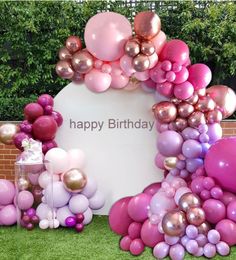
left=215, top=219, right=236, bottom=246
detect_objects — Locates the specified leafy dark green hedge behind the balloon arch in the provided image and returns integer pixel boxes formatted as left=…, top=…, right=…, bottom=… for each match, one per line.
left=0, top=1, right=236, bottom=120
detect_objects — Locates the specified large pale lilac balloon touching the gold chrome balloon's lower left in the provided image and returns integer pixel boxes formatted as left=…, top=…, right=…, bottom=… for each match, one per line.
left=44, top=181, right=71, bottom=208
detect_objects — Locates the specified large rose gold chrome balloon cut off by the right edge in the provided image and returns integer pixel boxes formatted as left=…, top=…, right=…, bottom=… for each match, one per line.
left=207, top=85, right=236, bottom=118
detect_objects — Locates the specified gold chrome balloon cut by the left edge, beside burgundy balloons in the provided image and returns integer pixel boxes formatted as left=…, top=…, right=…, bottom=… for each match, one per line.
left=0, top=124, right=20, bottom=145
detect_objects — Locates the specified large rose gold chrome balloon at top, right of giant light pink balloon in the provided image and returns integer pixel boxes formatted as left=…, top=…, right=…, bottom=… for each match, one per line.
left=134, top=11, right=161, bottom=40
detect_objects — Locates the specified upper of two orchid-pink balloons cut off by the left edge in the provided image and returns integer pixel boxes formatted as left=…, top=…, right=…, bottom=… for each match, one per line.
left=0, top=179, right=16, bottom=205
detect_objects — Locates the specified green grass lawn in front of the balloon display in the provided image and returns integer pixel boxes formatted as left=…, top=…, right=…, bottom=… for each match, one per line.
left=0, top=216, right=236, bottom=260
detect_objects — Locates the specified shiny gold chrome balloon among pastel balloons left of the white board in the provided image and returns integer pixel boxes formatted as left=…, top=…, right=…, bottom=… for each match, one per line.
left=62, top=168, right=87, bottom=193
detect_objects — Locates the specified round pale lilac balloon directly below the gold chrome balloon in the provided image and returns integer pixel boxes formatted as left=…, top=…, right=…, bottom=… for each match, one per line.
left=69, top=194, right=89, bottom=214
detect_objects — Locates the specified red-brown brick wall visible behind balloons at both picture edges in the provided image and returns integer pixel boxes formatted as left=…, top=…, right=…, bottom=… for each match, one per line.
left=0, top=121, right=236, bottom=181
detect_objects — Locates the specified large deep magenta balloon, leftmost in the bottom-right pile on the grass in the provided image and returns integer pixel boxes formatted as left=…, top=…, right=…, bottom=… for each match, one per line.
left=109, top=197, right=133, bottom=236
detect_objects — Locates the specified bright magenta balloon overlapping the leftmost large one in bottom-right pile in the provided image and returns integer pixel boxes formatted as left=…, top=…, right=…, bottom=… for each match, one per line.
left=128, top=193, right=151, bottom=222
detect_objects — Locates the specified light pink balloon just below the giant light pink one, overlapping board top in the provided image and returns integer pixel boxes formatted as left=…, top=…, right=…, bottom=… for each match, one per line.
left=84, top=69, right=112, bottom=92
